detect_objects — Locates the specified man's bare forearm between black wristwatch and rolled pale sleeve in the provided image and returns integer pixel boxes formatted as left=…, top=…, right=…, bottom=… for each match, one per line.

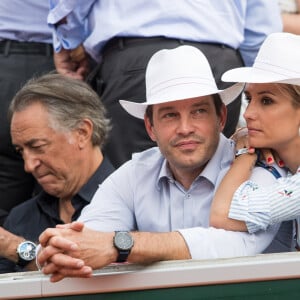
left=128, top=231, right=191, bottom=264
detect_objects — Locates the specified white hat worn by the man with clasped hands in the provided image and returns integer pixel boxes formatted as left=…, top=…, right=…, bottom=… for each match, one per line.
left=120, top=45, right=244, bottom=119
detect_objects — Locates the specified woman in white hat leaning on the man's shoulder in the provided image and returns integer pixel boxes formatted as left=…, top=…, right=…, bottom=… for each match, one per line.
left=211, top=33, right=300, bottom=240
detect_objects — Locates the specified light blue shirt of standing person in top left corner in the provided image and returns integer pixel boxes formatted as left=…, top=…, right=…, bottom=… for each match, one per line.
left=0, top=0, right=52, bottom=44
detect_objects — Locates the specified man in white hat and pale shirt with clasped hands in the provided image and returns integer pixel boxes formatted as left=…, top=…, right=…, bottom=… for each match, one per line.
left=37, top=46, right=284, bottom=281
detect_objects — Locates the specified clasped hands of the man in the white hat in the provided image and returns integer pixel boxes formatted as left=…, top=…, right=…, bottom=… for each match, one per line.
left=37, top=222, right=117, bottom=282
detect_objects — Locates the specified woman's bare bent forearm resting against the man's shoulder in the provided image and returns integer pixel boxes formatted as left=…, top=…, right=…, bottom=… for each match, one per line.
left=210, top=154, right=256, bottom=231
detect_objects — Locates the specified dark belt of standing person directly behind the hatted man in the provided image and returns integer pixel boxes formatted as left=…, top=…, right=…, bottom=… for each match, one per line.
left=102, top=36, right=230, bottom=55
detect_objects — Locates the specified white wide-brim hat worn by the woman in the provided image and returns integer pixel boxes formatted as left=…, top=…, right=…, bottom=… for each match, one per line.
left=222, top=32, right=300, bottom=85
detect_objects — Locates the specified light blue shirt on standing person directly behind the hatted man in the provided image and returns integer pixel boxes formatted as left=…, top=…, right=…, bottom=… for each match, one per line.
left=48, top=0, right=282, bottom=65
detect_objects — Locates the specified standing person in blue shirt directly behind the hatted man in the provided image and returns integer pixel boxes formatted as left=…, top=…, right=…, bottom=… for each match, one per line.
left=48, top=0, right=282, bottom=167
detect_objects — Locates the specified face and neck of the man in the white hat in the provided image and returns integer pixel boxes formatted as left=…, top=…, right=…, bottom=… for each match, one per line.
left=145, top=96, right=226, bottom=189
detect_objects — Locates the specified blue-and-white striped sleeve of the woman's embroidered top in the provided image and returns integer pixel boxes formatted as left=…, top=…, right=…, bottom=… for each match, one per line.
left=229, top=166, right=300, bottom=233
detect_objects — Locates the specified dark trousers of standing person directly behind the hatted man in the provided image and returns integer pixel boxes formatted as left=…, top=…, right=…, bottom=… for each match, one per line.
left=93, top=37, right=243, bottom=167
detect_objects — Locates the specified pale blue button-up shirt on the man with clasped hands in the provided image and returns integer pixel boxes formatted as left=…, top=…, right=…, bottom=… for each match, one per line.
left=79, top=135, right=279, bottom=259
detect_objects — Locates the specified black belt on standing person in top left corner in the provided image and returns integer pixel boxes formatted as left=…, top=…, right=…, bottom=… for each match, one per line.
left=0, top=40, right=53, bottom=56
